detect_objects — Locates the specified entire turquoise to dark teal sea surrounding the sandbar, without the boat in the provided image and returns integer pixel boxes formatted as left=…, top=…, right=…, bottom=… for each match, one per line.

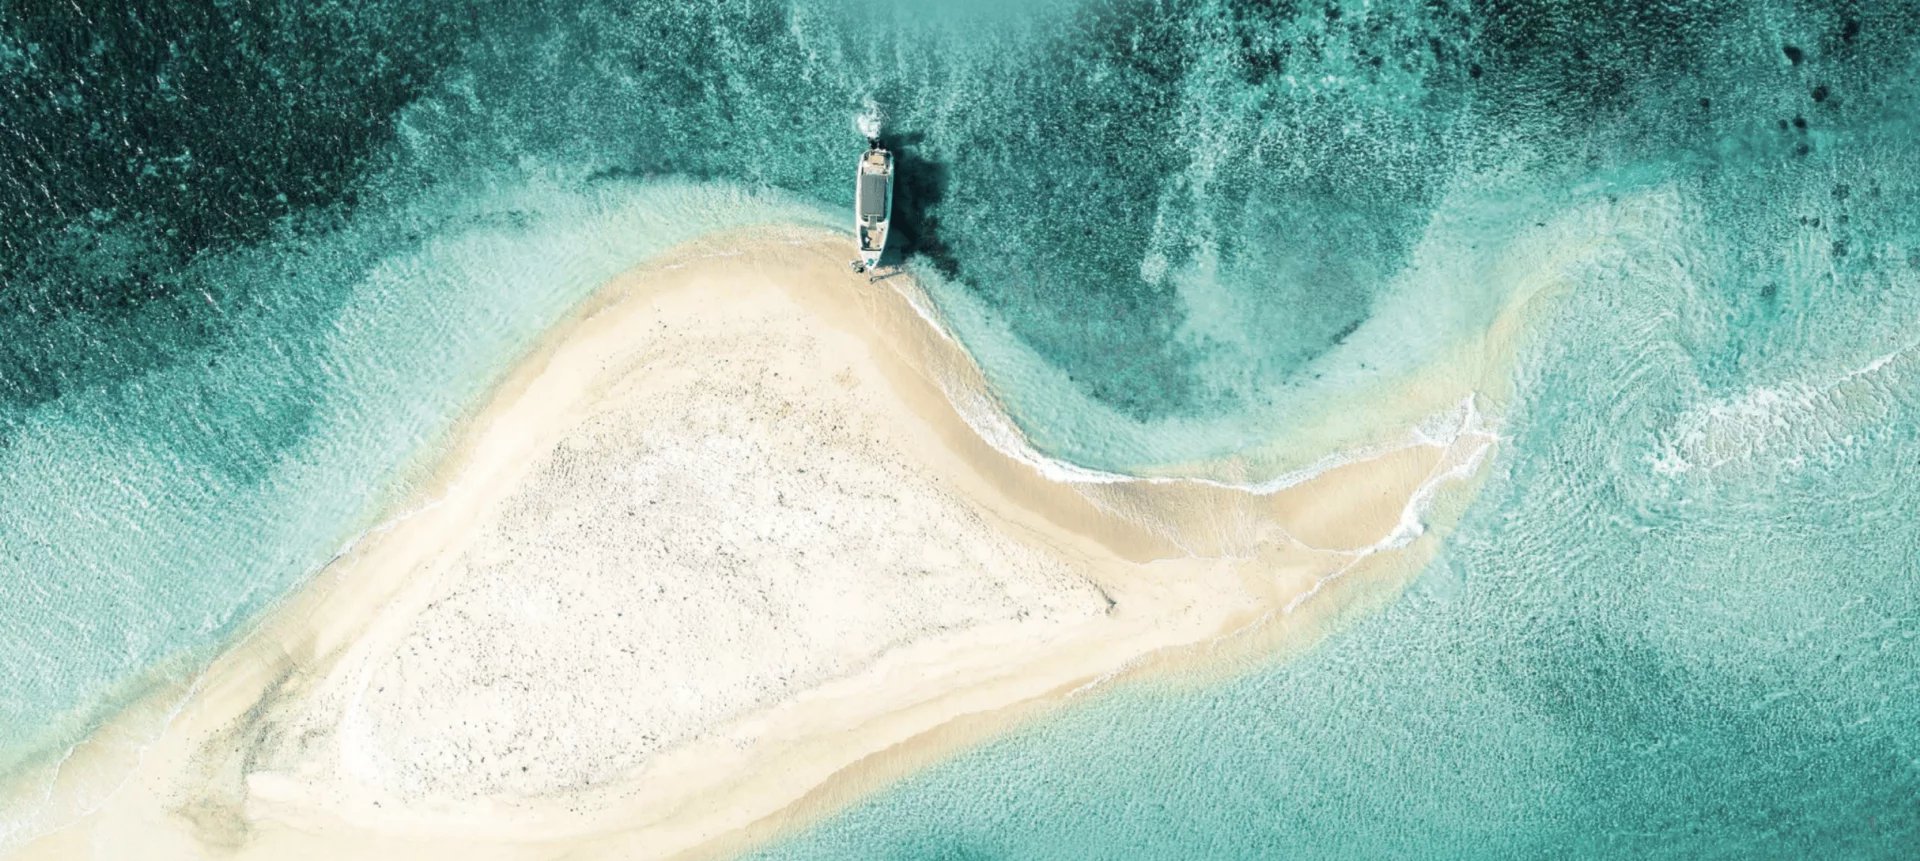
left=0, top=0, right=1920, bottom=859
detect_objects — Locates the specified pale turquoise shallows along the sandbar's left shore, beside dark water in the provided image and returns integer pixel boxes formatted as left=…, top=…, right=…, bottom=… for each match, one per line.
left=0, top=175, right=837, bottom=763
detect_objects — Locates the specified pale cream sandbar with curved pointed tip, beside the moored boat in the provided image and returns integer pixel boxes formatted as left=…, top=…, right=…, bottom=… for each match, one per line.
left=4, top=231, right=1496, bottom=861
